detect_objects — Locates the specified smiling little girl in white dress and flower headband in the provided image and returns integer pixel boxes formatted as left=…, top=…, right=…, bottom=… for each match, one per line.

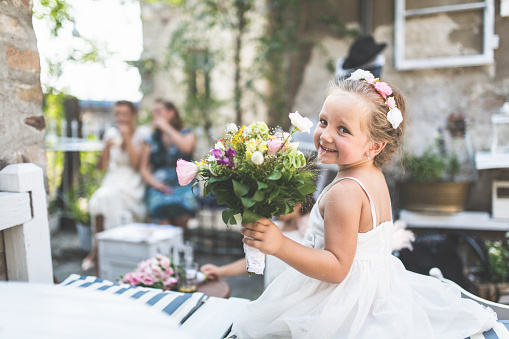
left=232, top=70, right=496, bottom=339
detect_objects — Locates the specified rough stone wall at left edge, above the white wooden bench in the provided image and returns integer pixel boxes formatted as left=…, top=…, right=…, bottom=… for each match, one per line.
left=0, top=0, right=46, bottom=280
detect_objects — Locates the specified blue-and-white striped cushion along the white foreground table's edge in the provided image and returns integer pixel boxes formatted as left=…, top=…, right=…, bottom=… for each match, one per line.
left=59, top=274, right=205, bottom=324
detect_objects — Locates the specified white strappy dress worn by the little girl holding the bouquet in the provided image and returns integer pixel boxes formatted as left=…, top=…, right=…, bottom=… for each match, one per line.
left=232, top=178, right=497, bottom=339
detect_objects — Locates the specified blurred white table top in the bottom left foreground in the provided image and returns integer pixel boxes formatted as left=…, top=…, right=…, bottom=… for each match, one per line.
left=0, top=282, right=195, bottom=339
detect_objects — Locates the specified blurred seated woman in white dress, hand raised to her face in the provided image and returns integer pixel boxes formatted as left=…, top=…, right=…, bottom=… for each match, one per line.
left=81, top=100, right=150, bottom=271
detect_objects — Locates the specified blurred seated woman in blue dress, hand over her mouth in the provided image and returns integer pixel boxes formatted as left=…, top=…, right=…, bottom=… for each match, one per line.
left=140, top=100, right=196, bottom=227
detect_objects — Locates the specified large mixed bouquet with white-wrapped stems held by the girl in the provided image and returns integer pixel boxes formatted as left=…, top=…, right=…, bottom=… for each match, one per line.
left=177, top=112, right=316, bottom=274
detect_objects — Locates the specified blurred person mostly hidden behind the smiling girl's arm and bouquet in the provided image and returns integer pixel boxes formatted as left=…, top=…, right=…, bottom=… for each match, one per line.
left=200, top=199, right=314, bottom=287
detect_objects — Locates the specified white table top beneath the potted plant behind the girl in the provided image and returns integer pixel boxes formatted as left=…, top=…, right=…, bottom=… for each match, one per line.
left=399, top=210, right=509, bottom=231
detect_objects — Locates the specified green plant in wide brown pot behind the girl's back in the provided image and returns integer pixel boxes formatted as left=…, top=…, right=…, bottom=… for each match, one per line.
left=399, top=134, right=472, bottom=213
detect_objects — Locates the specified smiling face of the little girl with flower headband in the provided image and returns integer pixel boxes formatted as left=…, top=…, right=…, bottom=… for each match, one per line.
left=314, top=91, right=372, bottom=166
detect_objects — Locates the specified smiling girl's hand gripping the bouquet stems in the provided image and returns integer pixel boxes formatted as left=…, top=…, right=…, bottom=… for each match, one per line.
left=240, top=218, right=285, bottom=255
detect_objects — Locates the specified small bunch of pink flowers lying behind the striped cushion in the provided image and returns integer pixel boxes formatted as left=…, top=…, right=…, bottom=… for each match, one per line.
left=118, top=254, right=179, bottom=290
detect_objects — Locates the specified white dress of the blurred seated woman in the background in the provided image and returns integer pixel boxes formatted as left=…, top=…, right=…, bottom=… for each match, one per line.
left=89, top=126, right=150, bottom=230
